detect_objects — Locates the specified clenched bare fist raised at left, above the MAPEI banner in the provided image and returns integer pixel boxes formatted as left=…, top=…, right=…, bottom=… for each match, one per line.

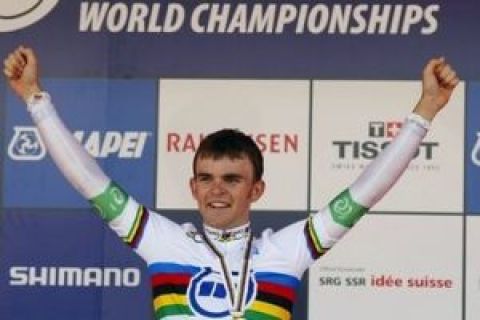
left=3, top=46, right=41, bottom=102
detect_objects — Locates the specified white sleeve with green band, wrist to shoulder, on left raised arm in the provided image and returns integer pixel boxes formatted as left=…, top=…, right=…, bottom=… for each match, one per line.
left=28, top=93, right=188, bottom=262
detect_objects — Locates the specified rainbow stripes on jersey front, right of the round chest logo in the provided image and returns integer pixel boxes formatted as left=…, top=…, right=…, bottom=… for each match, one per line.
left=245, top=272, right=300, bottom=320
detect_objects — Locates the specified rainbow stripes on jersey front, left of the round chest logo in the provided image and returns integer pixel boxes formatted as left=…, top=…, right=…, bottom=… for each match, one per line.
left=148, top=263, right=200, bottom=319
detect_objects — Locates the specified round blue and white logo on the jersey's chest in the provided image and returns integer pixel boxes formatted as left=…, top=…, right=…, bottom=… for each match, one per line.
left=187, top=267, right=256, bottom=319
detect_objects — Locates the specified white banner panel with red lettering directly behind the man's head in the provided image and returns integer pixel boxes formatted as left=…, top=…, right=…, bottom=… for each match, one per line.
left=156, top=79, right=309, bottom=210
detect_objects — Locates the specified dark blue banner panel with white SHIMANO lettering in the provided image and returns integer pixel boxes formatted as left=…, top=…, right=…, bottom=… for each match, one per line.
left=0, top=210, right=152, bottom=320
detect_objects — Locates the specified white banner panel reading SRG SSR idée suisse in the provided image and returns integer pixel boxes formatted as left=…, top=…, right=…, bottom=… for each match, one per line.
left=309, top=215, right=464, bottom=320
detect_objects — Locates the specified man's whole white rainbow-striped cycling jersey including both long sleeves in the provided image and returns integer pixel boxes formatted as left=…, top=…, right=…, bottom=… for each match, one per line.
left=28, top=93, right=427, bottom=320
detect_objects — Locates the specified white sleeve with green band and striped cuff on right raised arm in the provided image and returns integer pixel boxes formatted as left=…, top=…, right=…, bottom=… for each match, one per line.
left=306, top=115, right=428, bottom=258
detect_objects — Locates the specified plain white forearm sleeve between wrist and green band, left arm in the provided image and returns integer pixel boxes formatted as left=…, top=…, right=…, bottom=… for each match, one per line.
left=28, top=94, right=110, bottom=199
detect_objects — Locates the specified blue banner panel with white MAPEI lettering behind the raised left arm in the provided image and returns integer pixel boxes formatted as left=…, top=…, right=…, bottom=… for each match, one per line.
left=3, top=79, right=156, bottom=208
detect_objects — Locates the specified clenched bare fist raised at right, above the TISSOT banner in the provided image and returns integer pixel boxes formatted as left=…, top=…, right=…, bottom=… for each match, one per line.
left=413, top=57, right=460, bottom=121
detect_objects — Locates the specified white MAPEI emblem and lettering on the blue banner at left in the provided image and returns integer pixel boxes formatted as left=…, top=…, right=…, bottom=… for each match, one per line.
left=8, top=126, right=151, bottom=161
